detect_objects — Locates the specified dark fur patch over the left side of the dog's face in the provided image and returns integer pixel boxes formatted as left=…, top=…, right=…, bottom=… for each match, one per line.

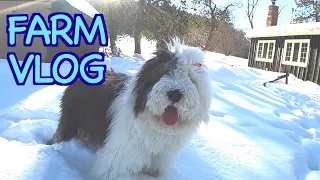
left=132, top=50, right=177, bottom=116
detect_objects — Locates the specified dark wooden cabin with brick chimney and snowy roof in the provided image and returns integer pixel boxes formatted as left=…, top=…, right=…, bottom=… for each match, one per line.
left=246, top=1, right=320, bottom=85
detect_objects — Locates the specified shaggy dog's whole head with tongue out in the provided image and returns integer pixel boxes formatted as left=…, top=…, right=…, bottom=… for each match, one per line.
left=133, top=39, right=211, bottom=135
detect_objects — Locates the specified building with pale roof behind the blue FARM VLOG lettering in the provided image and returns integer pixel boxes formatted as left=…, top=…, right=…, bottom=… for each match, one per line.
left=0, top=0, right=99, bottom=62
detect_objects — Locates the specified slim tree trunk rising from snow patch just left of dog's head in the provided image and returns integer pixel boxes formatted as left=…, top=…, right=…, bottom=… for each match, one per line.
left=134, top=0, right=145, bottom=54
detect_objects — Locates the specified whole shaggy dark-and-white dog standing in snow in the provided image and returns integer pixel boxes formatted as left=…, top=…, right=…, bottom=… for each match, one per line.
left=51, top=39, right=211, bottom=180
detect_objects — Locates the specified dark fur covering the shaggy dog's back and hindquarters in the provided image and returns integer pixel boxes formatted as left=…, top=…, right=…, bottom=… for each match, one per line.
left=48, top=71, right=129, bottom=146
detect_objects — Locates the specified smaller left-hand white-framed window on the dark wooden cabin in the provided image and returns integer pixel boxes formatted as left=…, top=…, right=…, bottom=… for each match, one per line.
left=256, top=40, right=276, bottom=62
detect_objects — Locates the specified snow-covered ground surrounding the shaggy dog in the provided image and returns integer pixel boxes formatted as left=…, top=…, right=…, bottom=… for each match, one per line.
left=0, top=38, right=320, bottom=180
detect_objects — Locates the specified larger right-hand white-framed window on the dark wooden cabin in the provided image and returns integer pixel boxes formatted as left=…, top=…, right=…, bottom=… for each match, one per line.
left=282, top=39, right=310, bottom=67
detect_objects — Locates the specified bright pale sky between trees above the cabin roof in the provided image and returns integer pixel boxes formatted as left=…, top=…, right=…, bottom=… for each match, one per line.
left=172, top=0, right=295, bottom=31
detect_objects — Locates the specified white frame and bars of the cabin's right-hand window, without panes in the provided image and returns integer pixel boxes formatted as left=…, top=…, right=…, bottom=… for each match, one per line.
left=281, top=39, right=310, bottom=67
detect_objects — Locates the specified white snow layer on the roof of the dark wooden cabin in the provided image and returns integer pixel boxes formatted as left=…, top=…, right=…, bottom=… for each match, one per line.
left=246, top=22, right=320, bottom=38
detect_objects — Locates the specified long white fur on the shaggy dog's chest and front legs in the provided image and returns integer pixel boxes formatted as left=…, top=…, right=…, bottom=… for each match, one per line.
left=92, top=83, right=192, bottom=180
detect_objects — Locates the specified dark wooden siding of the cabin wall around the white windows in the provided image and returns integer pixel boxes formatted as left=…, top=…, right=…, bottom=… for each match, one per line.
left=248, top=35, right=320, bottom=85
